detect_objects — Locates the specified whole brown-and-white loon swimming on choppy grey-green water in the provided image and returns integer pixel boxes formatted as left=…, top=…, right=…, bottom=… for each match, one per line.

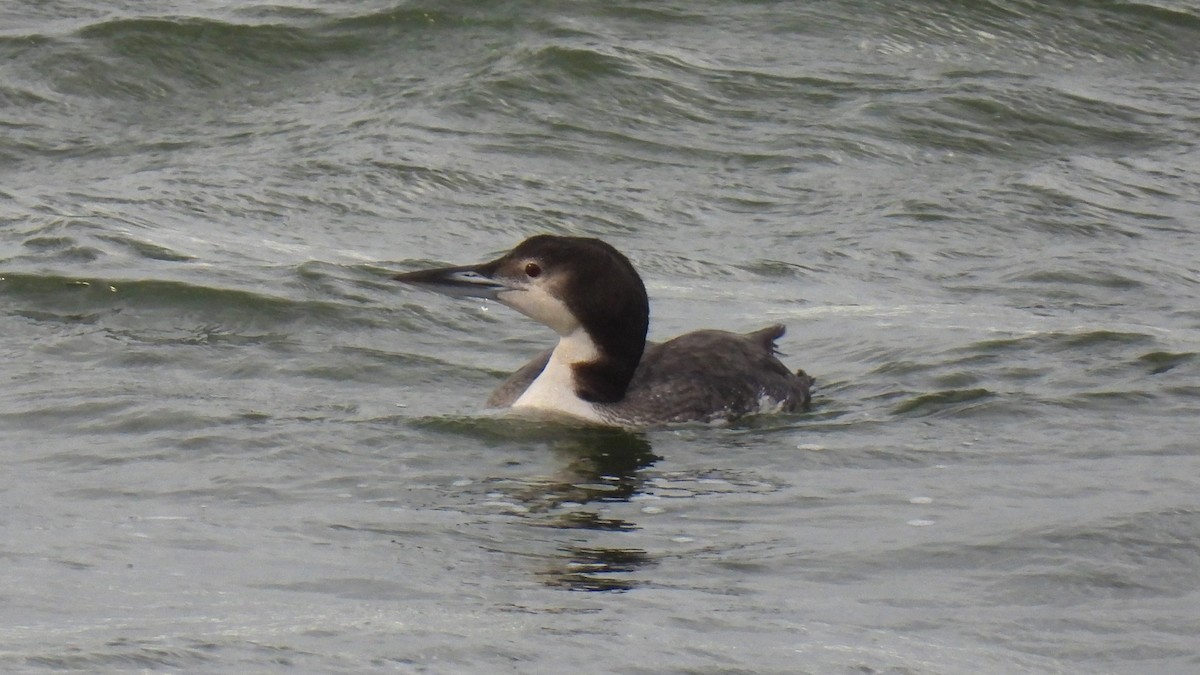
left=392, top=234, right=812, bottom=428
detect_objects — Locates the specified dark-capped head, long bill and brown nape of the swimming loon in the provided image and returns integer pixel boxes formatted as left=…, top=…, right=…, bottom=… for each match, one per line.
left=392, top=234, right=649, bottom=402
